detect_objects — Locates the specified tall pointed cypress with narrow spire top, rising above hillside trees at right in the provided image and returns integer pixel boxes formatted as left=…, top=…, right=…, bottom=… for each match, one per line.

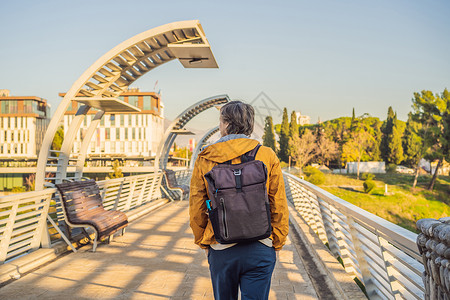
left=381, top=106, right=403, bottom=165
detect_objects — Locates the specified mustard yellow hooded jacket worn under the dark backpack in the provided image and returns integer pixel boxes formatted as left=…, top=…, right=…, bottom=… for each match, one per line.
left=189, top=138, right=289, bottom=250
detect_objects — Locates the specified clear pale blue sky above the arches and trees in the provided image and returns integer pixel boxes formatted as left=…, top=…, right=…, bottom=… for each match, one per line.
left=0, top=0, right=450, bottom=128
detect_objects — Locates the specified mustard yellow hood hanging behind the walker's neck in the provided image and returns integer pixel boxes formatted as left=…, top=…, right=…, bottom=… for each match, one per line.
left=198, top=138, right=259, bottom=164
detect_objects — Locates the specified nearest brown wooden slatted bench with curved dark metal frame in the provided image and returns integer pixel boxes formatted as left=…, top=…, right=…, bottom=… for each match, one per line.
left=56, top=179, right=128, bottom=251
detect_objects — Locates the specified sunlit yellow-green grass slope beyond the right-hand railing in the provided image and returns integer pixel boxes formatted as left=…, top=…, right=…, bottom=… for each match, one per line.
left=312, top=174, right=450, bottom=232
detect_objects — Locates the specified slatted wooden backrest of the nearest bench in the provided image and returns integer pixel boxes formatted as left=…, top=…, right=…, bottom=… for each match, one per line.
left=56, top=179, right=105, bottom=222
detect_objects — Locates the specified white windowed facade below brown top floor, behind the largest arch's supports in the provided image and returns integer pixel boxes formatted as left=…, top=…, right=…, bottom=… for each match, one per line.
left=64, top=113, right=164, bottom=157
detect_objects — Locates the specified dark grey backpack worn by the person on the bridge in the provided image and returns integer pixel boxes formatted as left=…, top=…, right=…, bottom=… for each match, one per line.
left=205, top=145, right=272, bottom=244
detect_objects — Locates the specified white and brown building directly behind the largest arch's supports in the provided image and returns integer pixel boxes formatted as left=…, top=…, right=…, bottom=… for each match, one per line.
left=60, top=88, right=164, bottom=158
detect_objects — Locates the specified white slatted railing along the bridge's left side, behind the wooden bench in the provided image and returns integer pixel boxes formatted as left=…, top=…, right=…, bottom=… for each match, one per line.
left=0, top=173, right=162, bottom=264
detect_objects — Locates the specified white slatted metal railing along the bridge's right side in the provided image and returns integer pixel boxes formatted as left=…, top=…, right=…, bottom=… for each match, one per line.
left=284, top=173, right=425, bottom=299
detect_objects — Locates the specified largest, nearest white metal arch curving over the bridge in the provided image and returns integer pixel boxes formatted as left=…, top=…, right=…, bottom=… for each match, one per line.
left=36, top=20, right=218, bottom=190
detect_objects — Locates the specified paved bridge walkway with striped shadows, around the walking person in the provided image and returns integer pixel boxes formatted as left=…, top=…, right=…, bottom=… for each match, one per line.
left=0, top=201, right=317, bottom=299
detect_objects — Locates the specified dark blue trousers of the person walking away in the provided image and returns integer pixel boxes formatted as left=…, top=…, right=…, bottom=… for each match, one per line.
left=208, top=242, right=276, bottom=300
